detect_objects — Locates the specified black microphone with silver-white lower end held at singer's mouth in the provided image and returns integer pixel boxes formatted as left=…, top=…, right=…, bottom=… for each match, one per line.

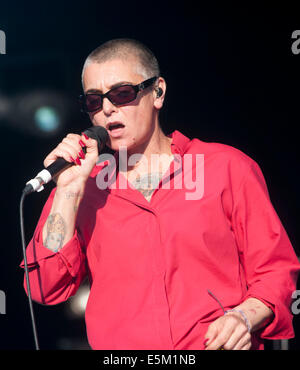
left=23, top=126, right=108, bottom=194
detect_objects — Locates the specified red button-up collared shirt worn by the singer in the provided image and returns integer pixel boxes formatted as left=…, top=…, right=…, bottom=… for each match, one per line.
left=22, top=131, right=299, bottom=350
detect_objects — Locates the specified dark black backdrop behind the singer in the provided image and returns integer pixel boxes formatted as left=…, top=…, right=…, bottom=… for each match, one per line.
left=0, top=1, right=300, bottom=349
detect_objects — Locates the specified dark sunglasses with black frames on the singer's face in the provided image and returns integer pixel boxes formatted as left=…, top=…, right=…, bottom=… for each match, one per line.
left=79, top=77, right=158, bottom=113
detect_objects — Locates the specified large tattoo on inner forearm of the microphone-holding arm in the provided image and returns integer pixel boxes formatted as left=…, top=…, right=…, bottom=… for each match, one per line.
left=44, top=213, right=66, bottom=252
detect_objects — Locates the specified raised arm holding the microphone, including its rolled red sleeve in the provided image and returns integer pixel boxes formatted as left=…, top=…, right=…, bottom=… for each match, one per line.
left=21, top=130, right=98, bottom=304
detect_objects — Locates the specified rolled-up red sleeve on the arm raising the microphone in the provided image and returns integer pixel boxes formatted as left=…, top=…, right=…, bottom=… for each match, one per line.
left=20, top=189, right=86, bottom=305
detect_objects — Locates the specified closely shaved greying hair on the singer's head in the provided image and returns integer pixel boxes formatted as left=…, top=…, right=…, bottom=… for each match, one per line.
left=82, top=38, right=160, bottom=81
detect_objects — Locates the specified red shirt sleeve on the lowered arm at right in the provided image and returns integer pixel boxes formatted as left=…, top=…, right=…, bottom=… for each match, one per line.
left=232, top=161, right=300, bottom=340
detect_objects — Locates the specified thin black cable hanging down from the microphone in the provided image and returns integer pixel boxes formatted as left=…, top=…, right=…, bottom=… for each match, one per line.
left=20, top=191, right=40, bottom=350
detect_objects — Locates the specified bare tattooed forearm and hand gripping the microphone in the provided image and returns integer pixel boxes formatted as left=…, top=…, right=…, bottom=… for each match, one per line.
left=43, top=130, right=98, bottom=252
